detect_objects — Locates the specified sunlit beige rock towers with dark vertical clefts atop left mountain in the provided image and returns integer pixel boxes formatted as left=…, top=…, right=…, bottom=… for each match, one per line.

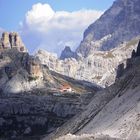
left=0, top=32, right=27, bottom=52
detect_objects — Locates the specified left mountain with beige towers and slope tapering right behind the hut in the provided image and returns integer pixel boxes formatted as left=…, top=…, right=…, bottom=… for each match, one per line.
left=0, top=33, right=98, bottom=94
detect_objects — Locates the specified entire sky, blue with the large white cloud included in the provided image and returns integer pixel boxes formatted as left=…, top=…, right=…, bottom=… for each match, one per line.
left=0, top=0, right=114, bottom=55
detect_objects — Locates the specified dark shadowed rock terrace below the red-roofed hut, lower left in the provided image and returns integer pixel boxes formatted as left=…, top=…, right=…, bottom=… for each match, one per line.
left=0, top=94, right=91, bottom=139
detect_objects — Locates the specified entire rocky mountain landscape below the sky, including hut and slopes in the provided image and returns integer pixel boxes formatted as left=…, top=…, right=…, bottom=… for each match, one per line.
left=0, top=0, right=140, bottom=140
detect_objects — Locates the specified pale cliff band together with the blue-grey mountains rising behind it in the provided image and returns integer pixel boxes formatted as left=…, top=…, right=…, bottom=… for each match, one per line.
left=36, top=0, right=140, bottom=87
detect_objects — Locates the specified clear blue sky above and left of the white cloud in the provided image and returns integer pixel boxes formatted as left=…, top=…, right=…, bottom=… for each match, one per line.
left=0, top=0, right=114, bottom=30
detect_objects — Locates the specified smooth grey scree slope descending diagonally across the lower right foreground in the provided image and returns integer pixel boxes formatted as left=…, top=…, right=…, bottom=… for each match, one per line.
left=43, top=54, right=140, bottom=140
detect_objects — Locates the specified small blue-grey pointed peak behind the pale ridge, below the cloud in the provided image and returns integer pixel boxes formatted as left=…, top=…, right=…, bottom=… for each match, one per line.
left=60, top=46, right=78, bottom=60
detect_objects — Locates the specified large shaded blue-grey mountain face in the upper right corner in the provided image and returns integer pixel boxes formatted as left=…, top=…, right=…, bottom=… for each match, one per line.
left=76, top=0, right=140, bottom=57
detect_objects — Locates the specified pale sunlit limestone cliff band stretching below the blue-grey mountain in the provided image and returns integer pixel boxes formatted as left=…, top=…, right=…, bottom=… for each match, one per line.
left=36, top=38, right=139, bottom=87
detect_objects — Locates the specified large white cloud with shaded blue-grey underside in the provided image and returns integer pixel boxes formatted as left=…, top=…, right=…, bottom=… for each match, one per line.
left=20, top=3, right=102, bottom=54
